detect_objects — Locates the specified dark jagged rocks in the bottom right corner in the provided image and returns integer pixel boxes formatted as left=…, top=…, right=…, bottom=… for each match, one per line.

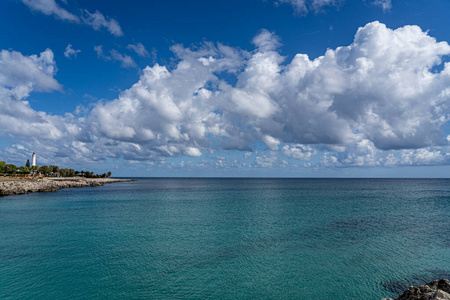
left=382, top=279, right=450, bottom=300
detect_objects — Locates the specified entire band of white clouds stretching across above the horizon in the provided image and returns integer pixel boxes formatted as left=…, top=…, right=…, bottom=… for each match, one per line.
left=0, top=20, right=450, bottom=168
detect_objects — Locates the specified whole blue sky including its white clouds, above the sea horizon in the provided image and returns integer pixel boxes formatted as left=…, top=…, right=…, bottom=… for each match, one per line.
left=0, top=0, right=450, bottom=177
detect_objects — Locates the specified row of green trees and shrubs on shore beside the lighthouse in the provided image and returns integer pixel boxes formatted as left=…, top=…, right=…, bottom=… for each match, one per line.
left=0, top=160, right=111, bottom=178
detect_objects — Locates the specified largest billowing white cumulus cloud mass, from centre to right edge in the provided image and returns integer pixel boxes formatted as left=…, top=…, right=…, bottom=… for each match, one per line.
left=80, top=22, right=450, bottom=163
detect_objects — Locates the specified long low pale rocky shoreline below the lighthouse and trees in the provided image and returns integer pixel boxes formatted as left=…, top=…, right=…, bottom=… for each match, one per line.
left=0, top=177, right=135, bottom=196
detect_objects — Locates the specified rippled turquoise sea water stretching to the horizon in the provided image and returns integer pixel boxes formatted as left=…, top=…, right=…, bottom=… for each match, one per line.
left=0, top=179, right=450, bottom=299
